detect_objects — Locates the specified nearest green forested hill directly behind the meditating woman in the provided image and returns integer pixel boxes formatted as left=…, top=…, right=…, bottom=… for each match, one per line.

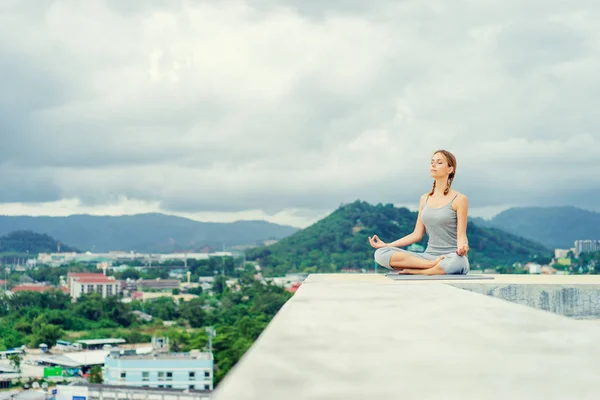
left=247, top=201, right=551, bottom=275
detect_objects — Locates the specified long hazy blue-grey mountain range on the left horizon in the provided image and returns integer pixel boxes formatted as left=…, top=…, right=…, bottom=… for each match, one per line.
left=0, top=213, right=298, bottom=253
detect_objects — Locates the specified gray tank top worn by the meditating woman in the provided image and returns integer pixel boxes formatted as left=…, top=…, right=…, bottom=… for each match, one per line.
left=421, top=195, right=458, bottom=255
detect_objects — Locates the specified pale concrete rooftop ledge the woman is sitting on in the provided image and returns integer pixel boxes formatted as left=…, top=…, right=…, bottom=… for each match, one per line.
left=213, top=274, right=600, bottom=400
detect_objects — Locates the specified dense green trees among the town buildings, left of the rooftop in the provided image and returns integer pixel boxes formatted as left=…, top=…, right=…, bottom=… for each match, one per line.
left=0, top=266, right=291, bottom=382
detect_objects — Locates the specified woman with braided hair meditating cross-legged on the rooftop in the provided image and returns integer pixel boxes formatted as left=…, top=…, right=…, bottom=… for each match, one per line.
left=369, top=150, right=469, bottom=275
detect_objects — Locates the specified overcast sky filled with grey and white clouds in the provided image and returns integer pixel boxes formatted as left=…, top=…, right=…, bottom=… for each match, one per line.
left=0, top=0, right=600, bottom=227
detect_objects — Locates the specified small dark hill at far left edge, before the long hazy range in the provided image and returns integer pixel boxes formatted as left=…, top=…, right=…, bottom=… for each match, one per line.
left=0, top=231, right=77, bottom=255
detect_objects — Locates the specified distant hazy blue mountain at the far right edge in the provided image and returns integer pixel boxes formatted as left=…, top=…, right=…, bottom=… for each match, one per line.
left=486, top=207, right=600, bottom=249
